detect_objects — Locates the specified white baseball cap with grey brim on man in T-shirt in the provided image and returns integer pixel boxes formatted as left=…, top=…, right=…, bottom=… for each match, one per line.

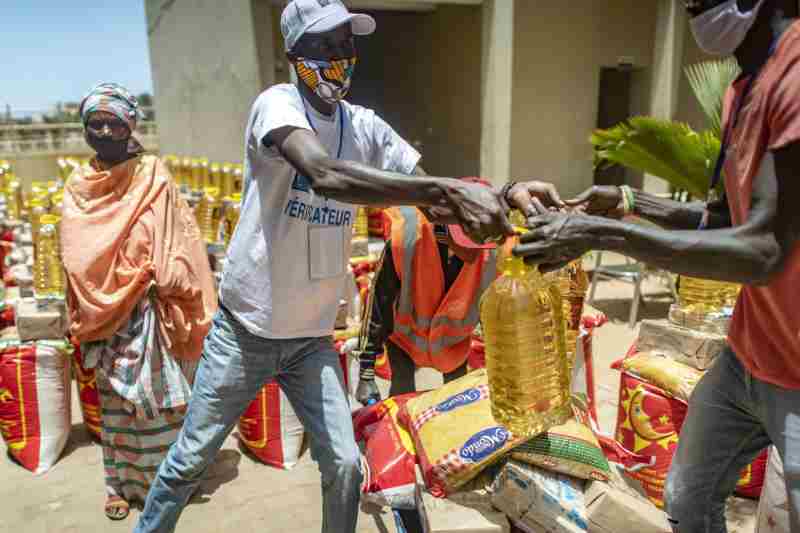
left=281, top=0, right=375, bottom=52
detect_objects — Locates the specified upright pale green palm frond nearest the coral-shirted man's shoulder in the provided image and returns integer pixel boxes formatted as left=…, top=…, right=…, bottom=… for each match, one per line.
left=686, top=58, right=741, bottom=137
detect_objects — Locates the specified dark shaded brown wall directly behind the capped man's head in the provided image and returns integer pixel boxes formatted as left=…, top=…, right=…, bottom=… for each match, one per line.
left=256, top=5, right=481, bottom=176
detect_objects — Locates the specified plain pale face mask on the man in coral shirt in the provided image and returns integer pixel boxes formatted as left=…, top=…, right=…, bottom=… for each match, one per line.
left=691, top=0, right=764, bottom=56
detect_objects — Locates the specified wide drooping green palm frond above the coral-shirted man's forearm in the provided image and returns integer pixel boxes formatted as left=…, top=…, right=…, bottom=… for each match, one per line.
left=591, top=117, right=720, bottom=198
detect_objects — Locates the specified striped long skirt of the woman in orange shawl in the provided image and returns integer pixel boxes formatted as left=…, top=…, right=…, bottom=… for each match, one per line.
left=97, top=371, right=186, bottom=503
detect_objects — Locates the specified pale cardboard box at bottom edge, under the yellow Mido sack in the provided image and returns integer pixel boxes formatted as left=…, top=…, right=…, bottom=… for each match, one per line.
left=417, top=492, right=511, bottom=533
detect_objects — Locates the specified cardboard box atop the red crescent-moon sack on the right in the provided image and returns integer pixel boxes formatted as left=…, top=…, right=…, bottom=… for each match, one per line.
left=636, top=320, right=726, bottom=370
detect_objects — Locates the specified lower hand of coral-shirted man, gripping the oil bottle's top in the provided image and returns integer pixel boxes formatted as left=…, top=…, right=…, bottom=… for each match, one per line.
left=514, top=213, right=600, bottom=272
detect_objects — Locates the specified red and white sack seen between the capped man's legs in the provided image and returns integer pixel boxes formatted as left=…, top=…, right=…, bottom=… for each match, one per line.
left=239, top=381, right=305, bottom=470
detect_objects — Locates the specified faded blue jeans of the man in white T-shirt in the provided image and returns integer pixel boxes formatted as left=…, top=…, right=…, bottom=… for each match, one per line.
left=134, top=308, right=362, bottom=533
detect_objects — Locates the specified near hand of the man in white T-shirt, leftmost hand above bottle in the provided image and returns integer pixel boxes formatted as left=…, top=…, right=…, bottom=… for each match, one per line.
left=447, top=180, right=514, bottom=243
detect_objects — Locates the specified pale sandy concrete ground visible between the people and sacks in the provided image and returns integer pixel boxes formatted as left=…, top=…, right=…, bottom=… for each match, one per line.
left=0, top=256, right=755, bottom=533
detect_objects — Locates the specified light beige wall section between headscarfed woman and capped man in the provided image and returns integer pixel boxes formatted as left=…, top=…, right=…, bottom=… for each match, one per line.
left=145, top=0, right=272, bottom=161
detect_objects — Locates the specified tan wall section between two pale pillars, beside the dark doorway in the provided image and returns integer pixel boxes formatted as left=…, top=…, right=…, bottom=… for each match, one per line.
left=511, top=0, right=656, bottom=194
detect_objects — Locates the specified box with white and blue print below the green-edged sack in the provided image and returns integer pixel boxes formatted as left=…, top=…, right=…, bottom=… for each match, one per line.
left=492, top=461, right=587, bottom=533
